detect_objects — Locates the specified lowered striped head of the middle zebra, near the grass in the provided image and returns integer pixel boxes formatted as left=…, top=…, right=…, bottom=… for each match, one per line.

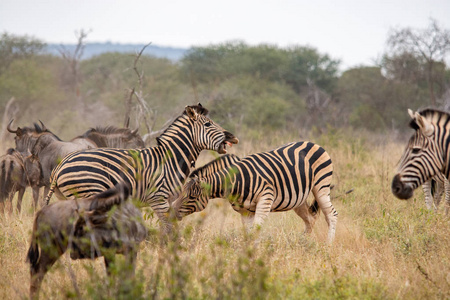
left=172, top=176, right=209, bottom=220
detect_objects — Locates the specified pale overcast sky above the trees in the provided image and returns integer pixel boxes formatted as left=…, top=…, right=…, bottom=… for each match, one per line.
left=0, top=0, right=450, bottom=68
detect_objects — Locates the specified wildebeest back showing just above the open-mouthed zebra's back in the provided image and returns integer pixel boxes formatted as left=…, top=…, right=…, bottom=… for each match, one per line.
left=72, top=126, right=145, bottom=149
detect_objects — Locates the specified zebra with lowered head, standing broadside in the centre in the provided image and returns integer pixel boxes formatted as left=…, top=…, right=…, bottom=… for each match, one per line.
left=173, top=141, right=338, bottom=243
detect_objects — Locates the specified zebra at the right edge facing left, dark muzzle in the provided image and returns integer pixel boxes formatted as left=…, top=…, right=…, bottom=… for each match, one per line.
left=391, top=109, right=450, bottom=214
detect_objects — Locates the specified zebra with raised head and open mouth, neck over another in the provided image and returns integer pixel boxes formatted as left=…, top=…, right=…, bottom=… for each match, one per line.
left=45, top=103, right=239, bottom=233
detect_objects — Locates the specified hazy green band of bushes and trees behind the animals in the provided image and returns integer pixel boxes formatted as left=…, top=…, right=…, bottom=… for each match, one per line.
left=0, top=20, right=450, bottom=143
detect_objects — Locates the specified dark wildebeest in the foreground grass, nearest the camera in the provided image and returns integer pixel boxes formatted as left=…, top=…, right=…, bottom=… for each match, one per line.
left=27, top=184, right=147, bottom=299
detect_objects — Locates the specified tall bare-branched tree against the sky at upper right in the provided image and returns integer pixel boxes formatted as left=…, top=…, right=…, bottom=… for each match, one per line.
left=387, top=19, right=450, bottom=106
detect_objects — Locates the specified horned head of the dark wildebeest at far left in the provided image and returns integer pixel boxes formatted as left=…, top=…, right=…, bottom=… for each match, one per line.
left=6, top=119, right=51, bottom=153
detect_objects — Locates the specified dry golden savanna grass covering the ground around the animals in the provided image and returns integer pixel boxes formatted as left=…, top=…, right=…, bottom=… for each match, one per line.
left=0, top=131, right=450, bottom=299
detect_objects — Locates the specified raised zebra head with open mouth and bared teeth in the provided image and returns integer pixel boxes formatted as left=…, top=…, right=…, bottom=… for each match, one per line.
left=185, top=103, right=239, bottom=154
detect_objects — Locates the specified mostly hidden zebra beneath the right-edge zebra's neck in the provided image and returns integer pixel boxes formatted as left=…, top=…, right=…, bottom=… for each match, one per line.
left=422, top=173, right=450, bottom=210
